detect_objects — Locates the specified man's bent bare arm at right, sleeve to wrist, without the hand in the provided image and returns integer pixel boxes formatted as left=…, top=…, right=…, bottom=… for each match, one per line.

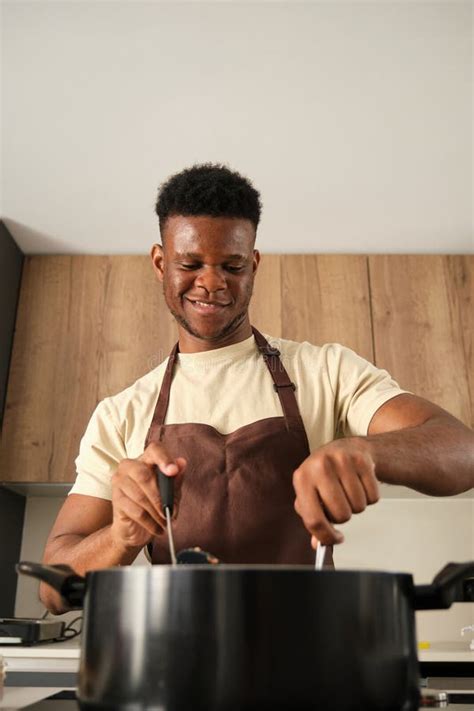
left=358, top=393, right=474, bottom=496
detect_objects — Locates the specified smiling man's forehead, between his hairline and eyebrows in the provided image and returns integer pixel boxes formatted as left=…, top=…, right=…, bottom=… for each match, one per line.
left=164, top=215, right=255, bottom=254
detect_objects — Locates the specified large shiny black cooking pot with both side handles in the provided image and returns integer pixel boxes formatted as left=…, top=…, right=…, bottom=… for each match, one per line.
left=18, top=562, right=474, bottom=711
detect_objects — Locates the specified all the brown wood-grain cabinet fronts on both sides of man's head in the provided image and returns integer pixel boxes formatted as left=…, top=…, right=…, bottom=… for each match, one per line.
left=0, top=255, right=474, bottom=482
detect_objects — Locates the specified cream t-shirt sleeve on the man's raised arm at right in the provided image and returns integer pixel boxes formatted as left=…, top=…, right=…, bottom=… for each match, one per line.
left=327, top=343, right=410, bottom=436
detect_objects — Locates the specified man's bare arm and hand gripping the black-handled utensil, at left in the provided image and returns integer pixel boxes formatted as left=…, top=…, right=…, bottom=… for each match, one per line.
left=40, top=443, right=186, bottom=614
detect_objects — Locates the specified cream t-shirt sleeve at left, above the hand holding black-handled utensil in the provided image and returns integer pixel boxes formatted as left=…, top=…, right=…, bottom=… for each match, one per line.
left=69, top=398, right=127, bottom=500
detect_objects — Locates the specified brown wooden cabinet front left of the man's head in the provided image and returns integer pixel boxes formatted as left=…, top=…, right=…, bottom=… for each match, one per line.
left=0, top=256, right=177, bottom=481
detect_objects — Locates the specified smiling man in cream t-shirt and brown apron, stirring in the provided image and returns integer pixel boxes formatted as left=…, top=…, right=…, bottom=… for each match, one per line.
left=40, top=164, right=474, bottom=612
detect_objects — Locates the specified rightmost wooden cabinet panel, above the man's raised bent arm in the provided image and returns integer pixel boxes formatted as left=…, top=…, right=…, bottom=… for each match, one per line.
left=369, top=255, right=474, bottom=427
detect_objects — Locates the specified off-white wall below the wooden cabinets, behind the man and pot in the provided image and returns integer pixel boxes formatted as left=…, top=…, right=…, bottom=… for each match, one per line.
left=15, top=496, right=474, bottom=649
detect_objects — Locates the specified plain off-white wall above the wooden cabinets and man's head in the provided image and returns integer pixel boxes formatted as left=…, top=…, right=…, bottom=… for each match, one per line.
left=2, top=0, right=474, bottom=254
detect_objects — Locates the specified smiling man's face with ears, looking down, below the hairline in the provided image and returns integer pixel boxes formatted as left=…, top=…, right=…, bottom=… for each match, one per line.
left=151, top=215, right=260, bottom=350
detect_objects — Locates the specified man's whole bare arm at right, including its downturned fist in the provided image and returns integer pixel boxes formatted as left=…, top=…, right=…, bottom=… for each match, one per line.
left=293, top=393, right=474, bottom=547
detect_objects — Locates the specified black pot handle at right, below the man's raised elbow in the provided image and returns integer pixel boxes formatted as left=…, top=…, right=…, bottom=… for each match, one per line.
left=414, top=561, right=474, bottom=610
